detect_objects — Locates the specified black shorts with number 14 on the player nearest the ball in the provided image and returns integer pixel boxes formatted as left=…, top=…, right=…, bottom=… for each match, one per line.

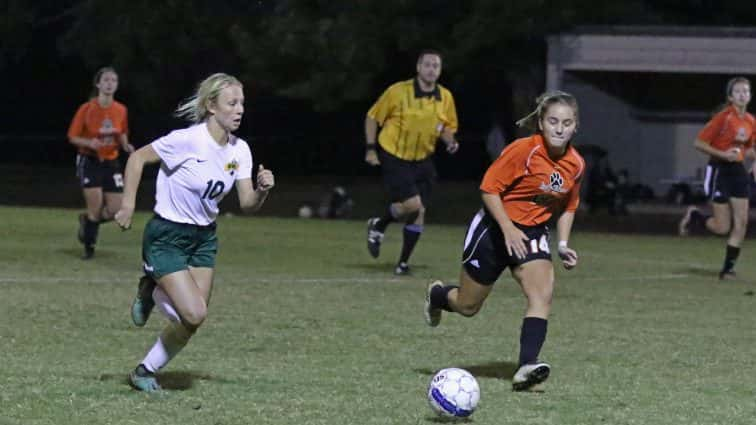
left=462, top=209, right=551, bottom=285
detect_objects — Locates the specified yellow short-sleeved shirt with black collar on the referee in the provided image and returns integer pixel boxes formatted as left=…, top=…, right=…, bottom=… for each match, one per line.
left=368, top=78, right=459, bottom=161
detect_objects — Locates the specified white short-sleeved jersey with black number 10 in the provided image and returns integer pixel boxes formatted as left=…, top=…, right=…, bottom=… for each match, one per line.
left=152, top=123, right=252, bottom=226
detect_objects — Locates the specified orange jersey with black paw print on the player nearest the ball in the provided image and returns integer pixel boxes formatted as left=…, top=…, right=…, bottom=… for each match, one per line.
left=480, top=134, right=585, bottom=226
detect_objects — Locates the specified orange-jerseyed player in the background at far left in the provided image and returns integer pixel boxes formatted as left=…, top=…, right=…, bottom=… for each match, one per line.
left=68, top=67, right=134, bottom=259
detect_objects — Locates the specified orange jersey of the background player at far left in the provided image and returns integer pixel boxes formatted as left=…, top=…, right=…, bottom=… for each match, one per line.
left=68, top=98, right=129, bottom=160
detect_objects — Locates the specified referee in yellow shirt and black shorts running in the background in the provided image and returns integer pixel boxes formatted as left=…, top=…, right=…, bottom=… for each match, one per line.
left=365, top=50, right=459, bottom=275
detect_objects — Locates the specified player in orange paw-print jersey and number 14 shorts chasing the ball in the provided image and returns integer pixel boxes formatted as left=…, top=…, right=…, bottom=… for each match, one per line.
left=425, top=91, right=585, bottom=391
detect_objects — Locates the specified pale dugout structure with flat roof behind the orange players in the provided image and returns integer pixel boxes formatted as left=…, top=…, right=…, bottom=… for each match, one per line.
left=546, top=27, right=756, bottom=195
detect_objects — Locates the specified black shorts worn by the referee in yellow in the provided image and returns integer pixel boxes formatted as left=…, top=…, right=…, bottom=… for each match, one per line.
left=378, top=149, right=436, bottom=206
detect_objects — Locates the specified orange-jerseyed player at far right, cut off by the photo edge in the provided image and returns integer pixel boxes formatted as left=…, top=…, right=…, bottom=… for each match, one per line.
left=679, top=77, right=756, bottom=280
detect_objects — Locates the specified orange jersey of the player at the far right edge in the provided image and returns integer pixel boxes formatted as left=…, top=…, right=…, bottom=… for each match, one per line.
left=698, top=105, right=756, bottom=161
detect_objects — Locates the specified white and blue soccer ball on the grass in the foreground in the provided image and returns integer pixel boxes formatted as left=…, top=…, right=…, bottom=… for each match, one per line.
left=428, top=367, right=480, bottom=418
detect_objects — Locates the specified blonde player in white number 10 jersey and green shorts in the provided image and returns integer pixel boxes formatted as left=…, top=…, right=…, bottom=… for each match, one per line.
left=115, top=73, right=275, bottom=392
